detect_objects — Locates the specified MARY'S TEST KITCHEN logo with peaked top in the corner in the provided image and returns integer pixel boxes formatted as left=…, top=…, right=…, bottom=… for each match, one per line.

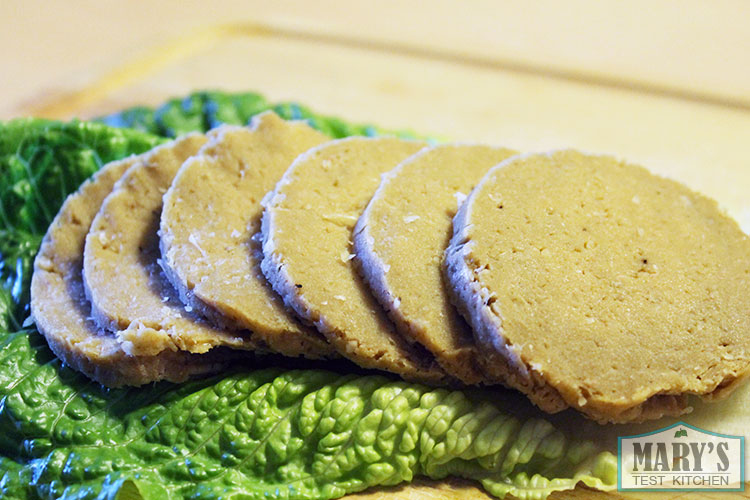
left=617, top=422, right=745, bottom=491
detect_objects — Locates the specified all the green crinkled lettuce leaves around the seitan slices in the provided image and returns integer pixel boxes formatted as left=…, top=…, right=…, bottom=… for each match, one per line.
left=0, top=93, right=616, bottom=500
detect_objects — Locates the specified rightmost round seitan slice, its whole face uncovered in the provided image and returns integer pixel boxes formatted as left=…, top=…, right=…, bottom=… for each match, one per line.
left=446, top=151, right=750, bottom=422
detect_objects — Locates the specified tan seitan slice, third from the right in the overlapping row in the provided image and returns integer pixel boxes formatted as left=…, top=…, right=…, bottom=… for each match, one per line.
left=261, top=137, right=444, bottom=381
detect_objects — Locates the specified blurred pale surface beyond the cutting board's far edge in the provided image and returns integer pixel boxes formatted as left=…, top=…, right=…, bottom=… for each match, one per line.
left=0, top=0, right=750, bottom=118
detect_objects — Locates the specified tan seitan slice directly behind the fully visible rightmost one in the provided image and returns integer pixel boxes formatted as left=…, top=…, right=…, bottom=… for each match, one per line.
left=354, top=144, right=516, bottom=384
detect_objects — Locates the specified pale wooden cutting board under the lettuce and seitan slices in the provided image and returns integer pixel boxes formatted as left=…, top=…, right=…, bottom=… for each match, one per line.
left=11, top=15, right=750, bottom=500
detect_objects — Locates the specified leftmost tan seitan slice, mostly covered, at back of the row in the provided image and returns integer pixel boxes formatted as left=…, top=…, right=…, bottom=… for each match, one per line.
left=31, top=157, right=229, bottom=387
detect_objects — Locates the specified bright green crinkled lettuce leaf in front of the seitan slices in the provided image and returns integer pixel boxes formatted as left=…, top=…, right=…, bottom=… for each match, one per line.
left=0, top=332, right=616, bottom=499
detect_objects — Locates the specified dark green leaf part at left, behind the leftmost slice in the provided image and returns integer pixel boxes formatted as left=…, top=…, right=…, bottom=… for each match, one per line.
left=0, top=119, right=164, bottom=329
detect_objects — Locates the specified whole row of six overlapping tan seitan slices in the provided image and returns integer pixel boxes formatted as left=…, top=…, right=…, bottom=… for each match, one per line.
left=27, top=113, right=750, bottom=422
